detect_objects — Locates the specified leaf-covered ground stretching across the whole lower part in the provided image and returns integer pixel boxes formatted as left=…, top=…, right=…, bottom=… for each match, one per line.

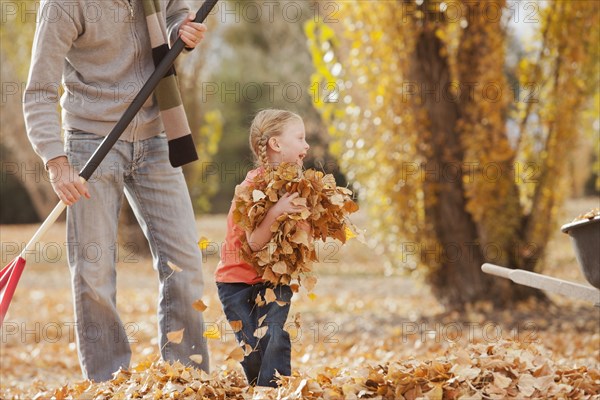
left=0, top=200, right=600, bottom=399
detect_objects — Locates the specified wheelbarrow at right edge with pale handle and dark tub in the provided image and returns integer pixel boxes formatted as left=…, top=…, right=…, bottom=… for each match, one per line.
left=481, top=216, right=600, bottom=307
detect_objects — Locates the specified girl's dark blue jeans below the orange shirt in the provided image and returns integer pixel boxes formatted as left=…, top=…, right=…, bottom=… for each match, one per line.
left=217, top=282, right=292, bottom=387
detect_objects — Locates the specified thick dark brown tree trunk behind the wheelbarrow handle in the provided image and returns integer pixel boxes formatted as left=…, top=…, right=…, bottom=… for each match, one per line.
left=411, top=8, right=541, bottom=309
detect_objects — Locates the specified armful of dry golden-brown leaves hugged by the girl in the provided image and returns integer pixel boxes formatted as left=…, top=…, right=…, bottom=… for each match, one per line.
left=233, top=164, right=358, bottom=290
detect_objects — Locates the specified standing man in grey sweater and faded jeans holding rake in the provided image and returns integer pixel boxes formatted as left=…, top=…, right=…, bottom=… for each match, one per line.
left=23, top=0, right=208, bottom=381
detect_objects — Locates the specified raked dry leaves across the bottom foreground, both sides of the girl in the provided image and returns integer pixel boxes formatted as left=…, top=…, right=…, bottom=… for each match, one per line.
left=2, top=341, right=600, bottom=400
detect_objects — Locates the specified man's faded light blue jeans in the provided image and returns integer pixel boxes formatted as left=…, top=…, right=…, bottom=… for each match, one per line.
left=65, top=132, right=209, bottom=381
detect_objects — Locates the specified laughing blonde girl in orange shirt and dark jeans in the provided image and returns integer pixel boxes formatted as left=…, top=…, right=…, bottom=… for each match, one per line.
left=215, top=110, right=309, bottom=387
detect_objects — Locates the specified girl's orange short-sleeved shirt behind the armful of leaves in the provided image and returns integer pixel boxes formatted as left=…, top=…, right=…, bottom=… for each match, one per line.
left=215, top=168, right=263, bottom=285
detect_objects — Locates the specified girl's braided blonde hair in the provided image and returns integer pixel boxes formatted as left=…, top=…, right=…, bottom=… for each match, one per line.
left=250, top=109, right=302, bottom=167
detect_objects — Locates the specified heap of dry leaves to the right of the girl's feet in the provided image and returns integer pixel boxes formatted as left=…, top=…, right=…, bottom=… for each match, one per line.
left=271, top=341, right=600, bottom=400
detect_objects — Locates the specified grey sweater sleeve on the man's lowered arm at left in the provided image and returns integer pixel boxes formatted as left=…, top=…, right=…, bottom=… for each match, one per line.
left=23, top=0, right=78, bottom=165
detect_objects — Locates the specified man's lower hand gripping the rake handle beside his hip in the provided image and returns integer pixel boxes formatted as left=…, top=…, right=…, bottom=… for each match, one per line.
left=47, top=156, right=91, bottom=206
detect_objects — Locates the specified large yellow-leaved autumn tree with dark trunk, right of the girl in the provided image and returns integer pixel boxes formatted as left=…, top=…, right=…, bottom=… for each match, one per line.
left=307, top=0, right=598, bottom=308
